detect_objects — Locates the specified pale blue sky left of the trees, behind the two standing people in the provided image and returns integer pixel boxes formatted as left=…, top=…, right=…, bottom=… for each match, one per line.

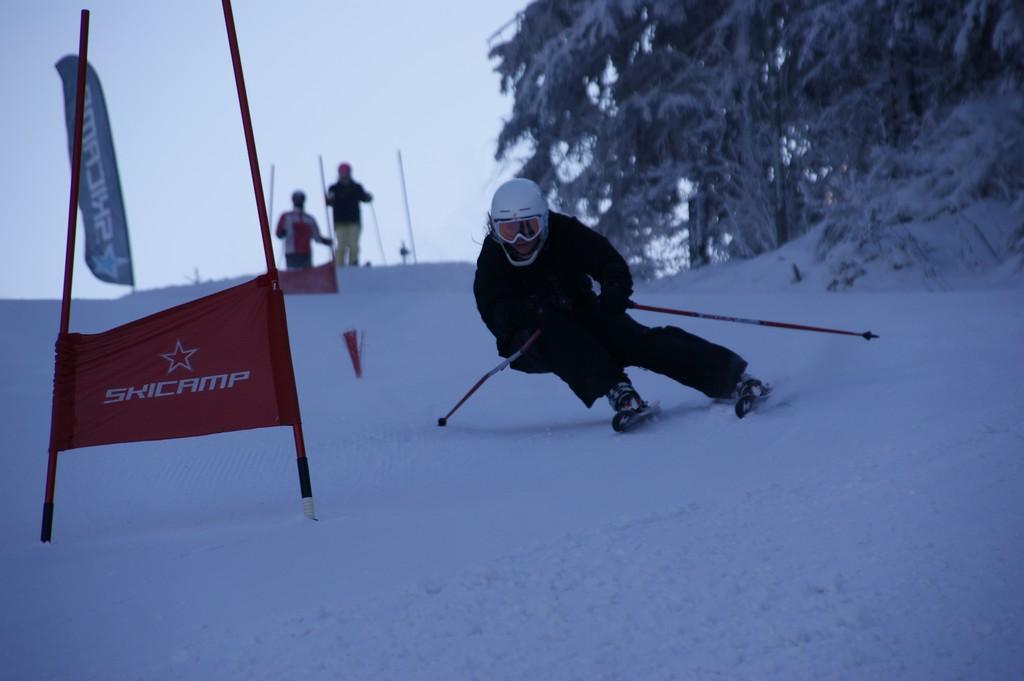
left=0, top=0, right=528, bottom=298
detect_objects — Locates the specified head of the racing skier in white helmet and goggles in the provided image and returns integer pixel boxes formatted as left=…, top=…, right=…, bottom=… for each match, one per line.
left=487, top=177, right=548, bottom=267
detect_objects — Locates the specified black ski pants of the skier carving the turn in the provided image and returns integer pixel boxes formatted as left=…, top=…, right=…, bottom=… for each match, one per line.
left=511, top=309, right=746, bottom=407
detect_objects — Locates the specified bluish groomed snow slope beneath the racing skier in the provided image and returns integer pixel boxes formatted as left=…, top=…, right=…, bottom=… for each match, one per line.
left=0, top=261, right=1024, bottom=680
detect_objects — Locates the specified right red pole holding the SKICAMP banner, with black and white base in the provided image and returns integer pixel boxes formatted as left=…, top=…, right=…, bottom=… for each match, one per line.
left=221, top=0, right=316, bottom=520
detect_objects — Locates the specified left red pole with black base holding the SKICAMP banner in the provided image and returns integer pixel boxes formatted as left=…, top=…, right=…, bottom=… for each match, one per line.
left=39, top=9, right=89, bottom=542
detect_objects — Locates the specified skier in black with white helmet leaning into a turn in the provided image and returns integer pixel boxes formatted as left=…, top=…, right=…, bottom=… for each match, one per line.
left=473, top=178, right=751, bottom=419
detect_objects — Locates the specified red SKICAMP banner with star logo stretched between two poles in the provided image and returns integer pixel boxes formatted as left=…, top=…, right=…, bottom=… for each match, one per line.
left=52, top=274, right=299, bottom=451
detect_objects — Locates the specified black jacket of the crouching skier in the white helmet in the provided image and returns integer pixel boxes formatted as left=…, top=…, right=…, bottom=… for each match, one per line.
left=473, top=212, right=633, bottom=350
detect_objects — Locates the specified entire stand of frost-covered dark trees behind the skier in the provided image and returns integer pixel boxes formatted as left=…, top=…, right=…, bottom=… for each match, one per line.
left=492, top=0, right=1024, bottom=275
